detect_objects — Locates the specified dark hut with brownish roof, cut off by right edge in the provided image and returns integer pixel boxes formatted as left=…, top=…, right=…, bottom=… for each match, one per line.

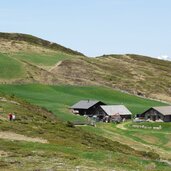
left=140, top=106, right=171, bottom=122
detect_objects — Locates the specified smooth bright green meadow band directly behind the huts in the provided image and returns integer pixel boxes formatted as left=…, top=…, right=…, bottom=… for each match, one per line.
left=0, top=84, right=165, bottom=121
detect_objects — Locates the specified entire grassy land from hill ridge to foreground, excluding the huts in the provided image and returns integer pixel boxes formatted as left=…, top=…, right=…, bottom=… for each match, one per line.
left=0, top=33, right=171, bottom=171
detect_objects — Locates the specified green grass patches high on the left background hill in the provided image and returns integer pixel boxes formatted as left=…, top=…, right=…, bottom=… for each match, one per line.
left=0, top=51, right=76, bottom=82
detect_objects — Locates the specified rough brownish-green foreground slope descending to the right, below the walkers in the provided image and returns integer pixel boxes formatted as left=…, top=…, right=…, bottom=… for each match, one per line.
left=0, top=96, right=169, bottom=171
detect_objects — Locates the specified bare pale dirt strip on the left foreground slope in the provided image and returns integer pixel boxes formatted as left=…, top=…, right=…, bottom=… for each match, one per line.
left=0, top=132, right=48, bottom=143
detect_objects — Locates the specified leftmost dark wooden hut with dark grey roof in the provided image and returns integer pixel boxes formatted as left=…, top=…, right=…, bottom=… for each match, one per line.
left=70, top=100, right=105, bottom=116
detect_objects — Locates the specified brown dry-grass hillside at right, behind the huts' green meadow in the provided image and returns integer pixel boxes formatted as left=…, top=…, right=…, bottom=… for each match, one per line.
left=53, top=54, right=171, bottom=102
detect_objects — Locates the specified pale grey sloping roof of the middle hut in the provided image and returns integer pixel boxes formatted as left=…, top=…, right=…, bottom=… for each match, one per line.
left=100, top=105, right=132, bottom=116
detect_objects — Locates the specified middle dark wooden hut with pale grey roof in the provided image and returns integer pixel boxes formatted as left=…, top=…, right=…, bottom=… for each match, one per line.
left=97, top=105, right=132, bottom=120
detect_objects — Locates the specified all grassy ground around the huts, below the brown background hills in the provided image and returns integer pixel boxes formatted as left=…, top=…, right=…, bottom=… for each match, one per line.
left=0, top=85, right=171, bottom=171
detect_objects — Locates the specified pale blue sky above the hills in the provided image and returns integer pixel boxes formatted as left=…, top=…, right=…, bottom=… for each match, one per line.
left=0, top=0, right=171, bottom=57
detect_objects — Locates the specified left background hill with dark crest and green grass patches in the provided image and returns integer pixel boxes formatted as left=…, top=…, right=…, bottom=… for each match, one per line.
left=0, top=33, right=83, bottom=84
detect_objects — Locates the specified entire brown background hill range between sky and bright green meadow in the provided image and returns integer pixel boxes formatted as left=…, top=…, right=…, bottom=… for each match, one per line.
left=0, top=33, right=171, bottom=102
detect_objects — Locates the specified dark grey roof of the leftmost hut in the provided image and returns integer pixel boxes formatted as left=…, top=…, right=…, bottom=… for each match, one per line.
left=71, top=100, right=100, bottom=109
